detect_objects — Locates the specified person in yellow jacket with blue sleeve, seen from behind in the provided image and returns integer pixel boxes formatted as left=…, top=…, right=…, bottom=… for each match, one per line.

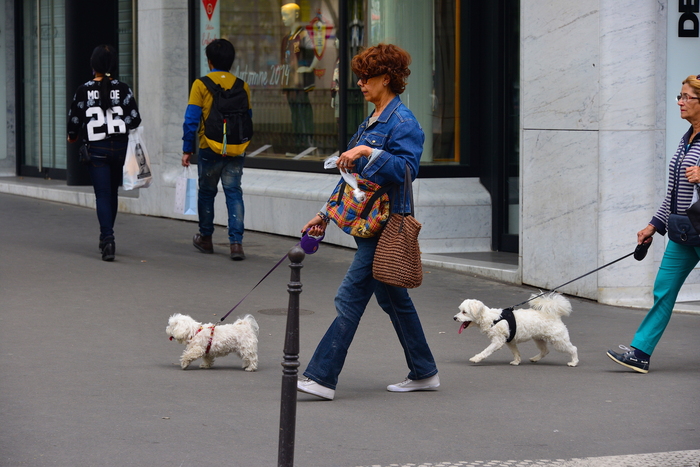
left=182, top=39, right=252, bottom=261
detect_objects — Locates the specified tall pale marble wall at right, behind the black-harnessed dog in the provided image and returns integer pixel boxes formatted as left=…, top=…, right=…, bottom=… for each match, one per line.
left=521, top=0, right=698, bottom=306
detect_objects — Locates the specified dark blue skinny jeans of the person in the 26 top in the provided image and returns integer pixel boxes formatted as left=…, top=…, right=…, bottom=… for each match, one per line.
left=88, top=139, right=127, bottom=240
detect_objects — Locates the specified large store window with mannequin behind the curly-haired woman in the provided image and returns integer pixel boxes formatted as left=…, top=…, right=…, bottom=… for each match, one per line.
left=193, top=0, right=461, bottom=170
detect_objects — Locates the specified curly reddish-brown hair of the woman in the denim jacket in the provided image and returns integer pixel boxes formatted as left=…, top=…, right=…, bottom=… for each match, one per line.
left=351, top=44, right=411, bottom=94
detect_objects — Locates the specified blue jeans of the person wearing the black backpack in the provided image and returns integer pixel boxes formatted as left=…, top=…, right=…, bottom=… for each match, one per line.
left=197, top=148, right=245, bottom=243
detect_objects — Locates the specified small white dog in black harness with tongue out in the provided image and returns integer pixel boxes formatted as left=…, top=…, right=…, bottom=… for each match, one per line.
left=454, top=293, right=578, bottom=366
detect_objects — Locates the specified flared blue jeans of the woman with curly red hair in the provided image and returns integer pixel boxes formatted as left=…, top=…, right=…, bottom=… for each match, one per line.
left=304, top=237, right=438, bottom=389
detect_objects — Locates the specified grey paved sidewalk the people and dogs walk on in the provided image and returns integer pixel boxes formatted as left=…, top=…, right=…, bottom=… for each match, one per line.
left=0, top=194, right=700, bottom=467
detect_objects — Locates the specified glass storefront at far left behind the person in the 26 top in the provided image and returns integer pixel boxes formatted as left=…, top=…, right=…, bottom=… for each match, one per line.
left=18, top=0, right=135, bottom=179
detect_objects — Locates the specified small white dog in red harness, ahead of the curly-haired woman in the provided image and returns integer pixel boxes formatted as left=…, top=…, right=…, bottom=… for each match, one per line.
left=165, top=313, right=259, bottom=371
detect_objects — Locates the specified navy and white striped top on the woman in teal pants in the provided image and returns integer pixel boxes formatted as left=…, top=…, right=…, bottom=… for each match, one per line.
left=649, top=127, right=700, bottom=235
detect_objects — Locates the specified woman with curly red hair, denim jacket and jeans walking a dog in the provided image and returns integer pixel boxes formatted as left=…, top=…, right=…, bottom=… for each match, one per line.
left=297, top=44, right=440, bottom=400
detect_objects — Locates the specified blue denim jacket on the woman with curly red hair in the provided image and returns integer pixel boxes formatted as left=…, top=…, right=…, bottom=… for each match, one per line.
left=348, top=96, right=425, bottom=213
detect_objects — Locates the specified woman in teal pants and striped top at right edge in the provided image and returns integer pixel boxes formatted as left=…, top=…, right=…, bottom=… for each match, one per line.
left=607, top=75, right=700, bottom=373
